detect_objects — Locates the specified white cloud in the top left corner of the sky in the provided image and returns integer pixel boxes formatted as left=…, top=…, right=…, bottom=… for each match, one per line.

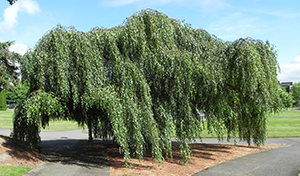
left=0, top=0, right=40, bottom=35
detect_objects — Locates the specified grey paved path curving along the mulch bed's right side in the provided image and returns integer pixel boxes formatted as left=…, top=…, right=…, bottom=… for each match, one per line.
left=194, top=138, right=300, bottom=176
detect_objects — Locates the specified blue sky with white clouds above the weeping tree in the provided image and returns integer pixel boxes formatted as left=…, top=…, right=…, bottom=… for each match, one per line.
left=0, top=0, right=300, bottom=82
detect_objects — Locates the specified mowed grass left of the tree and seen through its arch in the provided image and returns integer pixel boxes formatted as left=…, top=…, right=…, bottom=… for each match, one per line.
left=0, top=109, right=82, bottom=132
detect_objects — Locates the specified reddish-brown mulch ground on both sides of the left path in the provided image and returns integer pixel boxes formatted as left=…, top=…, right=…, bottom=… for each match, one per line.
left=0, top=135, right=281, bottom=176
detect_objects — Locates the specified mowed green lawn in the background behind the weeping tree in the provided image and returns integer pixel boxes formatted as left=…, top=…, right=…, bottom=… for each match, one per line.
left=0, top=110, right=300, bottom=138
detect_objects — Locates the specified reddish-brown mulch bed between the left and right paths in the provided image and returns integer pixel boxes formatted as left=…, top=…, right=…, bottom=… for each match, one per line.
left=107, top=144, right=281, bottom=176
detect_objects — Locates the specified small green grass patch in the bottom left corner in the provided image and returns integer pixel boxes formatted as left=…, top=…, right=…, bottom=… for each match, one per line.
left=0, top=165, right=31, bottom=176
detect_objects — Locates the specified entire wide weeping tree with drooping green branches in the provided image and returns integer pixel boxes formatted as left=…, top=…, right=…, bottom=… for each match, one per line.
left=13, top=9, right=280, bottom=162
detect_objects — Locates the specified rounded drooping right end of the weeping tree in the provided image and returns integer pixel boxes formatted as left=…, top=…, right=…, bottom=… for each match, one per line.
left=223, top=38, right=283, bottom=145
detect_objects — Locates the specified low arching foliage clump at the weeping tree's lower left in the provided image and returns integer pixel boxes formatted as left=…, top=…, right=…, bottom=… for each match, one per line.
left=12, top=90, right=64, bottom=146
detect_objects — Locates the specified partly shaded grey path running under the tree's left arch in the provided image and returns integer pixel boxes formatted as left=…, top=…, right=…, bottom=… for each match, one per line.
left=0, top=129, right=110, bottom=176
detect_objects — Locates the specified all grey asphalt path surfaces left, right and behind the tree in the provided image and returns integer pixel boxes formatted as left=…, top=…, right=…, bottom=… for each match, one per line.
left=0, top=129, right=300, bottom=176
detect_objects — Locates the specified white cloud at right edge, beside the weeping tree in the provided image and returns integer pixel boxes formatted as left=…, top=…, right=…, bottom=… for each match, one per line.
left=277, top=55, right=300, bottom=82
